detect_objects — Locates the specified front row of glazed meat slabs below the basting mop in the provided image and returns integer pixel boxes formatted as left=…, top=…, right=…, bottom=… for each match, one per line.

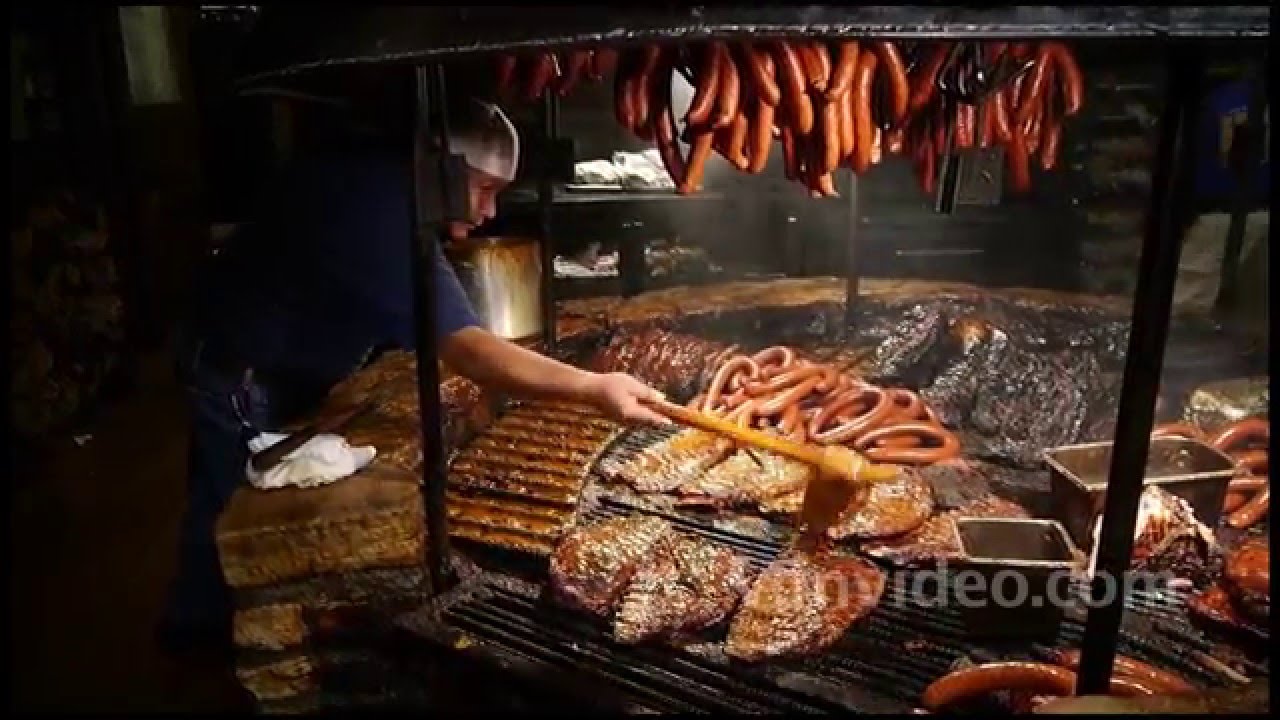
left=550, top=516, right=884, bottom=662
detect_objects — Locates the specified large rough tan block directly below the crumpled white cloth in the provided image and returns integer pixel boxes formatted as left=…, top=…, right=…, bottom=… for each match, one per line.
left=218, top=465, right=426, bottom=588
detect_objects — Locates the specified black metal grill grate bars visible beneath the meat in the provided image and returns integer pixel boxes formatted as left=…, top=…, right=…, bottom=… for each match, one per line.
left=401, top=428, right=1259, bottom=712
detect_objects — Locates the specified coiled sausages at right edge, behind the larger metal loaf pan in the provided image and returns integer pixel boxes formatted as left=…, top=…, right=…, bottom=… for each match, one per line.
left=1151, top=418, right=1271, bottom=528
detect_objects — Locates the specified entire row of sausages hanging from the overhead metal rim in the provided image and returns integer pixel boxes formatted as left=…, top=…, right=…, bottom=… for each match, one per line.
left=488, top=40, right=1083, bottom=197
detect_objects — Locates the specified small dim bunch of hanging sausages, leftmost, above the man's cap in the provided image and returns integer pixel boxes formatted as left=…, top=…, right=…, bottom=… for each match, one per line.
left=497, top=47, right=618, bottom=102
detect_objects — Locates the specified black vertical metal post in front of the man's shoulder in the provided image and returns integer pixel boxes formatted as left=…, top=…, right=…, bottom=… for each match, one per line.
left=410, top=64, right=453, bottom=593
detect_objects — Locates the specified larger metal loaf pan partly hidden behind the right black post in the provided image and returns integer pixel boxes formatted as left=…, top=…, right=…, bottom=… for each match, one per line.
left=1044, top=437, right=1235, bottom=551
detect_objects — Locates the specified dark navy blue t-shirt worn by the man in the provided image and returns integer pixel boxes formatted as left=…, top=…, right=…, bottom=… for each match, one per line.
left=197, top=144, right=480, bottom=383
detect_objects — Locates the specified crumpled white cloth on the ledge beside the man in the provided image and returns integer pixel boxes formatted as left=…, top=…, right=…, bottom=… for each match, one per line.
left=244, top=433, right=378, bottom=489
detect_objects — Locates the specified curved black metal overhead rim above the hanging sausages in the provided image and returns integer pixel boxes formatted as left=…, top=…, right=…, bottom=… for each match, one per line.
left=241, top=4, right=1271, bottom=83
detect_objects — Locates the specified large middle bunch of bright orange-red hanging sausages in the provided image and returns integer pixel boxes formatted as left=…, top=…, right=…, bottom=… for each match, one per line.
left=614, top=41, right=909, bottom=197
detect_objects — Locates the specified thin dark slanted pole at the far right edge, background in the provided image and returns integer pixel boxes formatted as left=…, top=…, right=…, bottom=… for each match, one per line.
left=1215, top=59, right=1267, bottom=311
